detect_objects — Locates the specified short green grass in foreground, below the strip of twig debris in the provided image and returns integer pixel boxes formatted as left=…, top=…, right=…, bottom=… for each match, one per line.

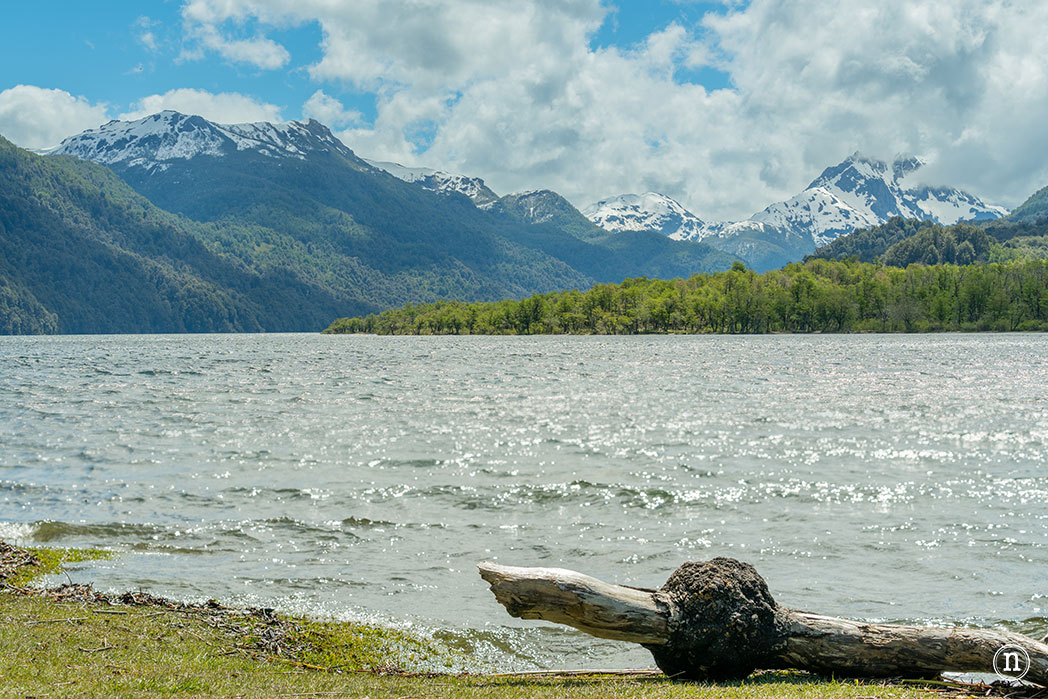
left=0, top=592, right=929, bottom=699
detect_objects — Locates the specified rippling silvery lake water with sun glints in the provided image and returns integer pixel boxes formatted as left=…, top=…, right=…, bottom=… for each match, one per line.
left=0, top=334, right=1048, bottom=669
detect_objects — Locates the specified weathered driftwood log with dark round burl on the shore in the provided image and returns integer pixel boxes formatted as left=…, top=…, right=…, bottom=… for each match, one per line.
left=478, top=559, right=1048, bottom=686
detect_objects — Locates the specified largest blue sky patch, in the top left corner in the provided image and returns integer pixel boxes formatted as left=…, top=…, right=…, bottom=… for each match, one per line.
left=0, top=0, right=326, bottom=118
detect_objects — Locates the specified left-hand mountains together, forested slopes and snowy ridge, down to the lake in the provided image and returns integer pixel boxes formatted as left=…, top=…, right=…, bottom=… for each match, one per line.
left=0, top=111, right=736, bottom=332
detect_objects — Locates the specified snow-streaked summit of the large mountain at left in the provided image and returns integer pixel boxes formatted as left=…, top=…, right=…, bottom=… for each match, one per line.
left=45, top=110, right=355, bottom=172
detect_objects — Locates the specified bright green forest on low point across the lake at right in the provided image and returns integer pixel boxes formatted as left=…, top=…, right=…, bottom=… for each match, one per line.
left=325, top=258, right=1048, bottom=334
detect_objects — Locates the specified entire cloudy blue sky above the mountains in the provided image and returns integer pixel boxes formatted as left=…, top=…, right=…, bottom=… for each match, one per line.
left=0, top=0, right=1048, bottom=221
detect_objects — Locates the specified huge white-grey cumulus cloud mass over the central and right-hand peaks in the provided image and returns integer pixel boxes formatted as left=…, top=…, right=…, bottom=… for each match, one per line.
left=183, top=0, right=1048, bottom=219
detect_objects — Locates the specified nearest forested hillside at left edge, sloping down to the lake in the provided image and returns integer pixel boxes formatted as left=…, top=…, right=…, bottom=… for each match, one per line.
left=0, top=138, right=354, bottom=333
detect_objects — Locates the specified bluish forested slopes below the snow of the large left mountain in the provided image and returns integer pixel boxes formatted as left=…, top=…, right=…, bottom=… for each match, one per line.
left=102, top=121, right=735, bottom=293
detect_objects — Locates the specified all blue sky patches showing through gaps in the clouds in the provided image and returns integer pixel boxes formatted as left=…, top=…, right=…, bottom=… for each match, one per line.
left=0, top=0, right=728, bottom=130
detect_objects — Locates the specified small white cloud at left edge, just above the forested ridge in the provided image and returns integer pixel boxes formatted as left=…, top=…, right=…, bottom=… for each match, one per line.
left=0, top=85, right=109, bottom=148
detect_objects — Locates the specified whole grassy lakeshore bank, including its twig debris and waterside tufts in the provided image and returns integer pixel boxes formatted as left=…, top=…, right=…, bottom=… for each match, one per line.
left=0, top=549, right=959, bottom=699
